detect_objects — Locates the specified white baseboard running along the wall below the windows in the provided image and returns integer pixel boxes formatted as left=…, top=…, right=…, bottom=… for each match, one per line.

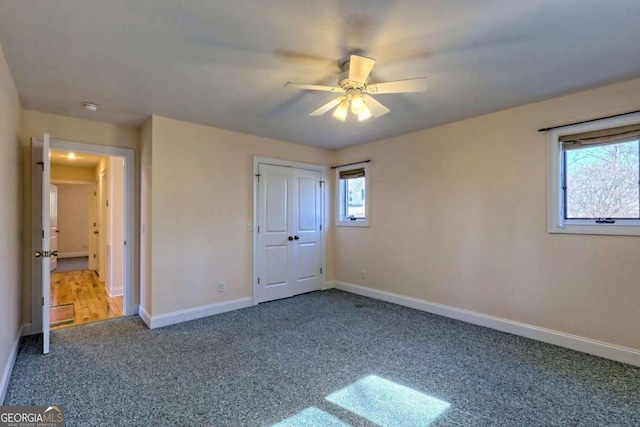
left=333, top=281, right=640, bottom=366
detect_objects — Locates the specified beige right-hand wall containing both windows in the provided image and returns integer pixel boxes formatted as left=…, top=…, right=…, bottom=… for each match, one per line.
left=334, top=80, right=640, bottom=349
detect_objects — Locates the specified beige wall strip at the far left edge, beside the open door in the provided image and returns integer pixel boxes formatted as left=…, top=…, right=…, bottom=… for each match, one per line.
left=0, top=41, right=22, bottom=403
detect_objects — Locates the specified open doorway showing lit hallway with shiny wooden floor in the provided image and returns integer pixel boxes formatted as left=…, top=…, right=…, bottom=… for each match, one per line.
left=49, top=149, right=124, bottom=330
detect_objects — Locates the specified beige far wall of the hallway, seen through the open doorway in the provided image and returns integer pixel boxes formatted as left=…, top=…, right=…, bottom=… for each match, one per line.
left=56, top=184, right=91, bottom=257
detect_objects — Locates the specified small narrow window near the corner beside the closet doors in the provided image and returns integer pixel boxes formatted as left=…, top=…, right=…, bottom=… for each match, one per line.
left=336, top=163, right=370, bottom=227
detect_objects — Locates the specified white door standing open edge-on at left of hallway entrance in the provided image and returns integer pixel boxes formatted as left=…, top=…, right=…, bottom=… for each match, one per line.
left=31, top=133, right=51, bottom=354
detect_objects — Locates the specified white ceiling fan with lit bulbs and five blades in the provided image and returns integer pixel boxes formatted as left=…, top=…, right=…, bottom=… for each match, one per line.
left=285, top=55, right=427, bottom=121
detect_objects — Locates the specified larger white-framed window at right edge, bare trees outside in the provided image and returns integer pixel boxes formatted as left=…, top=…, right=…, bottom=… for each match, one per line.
left=548, top=114, right=640, bottom=235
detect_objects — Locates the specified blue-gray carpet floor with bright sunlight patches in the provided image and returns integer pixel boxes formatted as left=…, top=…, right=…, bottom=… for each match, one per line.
left=5, top=290, right=640, bottom=427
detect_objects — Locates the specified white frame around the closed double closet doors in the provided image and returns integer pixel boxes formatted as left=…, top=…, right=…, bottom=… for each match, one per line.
left=249, top=156, right=327, bottom=305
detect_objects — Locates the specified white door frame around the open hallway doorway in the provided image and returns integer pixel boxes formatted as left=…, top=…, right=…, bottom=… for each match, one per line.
left=31, top=138, right=138, bottom=334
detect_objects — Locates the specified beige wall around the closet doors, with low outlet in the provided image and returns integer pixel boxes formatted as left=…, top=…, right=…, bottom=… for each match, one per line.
left=145, top=116, right=333, bottom=316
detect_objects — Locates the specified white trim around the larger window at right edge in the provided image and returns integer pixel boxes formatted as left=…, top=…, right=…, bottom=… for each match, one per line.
left=547, top=113, right=640, bottom=236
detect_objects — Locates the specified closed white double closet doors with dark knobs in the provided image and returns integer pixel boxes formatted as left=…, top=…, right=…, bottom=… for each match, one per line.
left=254, top=158, right=325, bottom=304
